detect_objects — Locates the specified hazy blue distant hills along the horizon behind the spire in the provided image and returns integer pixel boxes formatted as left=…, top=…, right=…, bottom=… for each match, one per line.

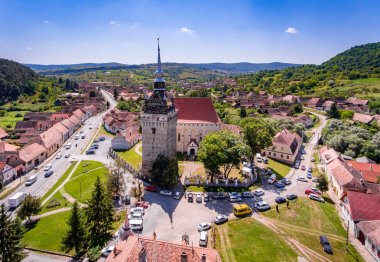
left=25, top=62, right=300, bottom=75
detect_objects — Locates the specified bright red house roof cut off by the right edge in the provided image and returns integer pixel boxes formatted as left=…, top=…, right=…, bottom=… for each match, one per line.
left=347, top=191, right=380, bottom=221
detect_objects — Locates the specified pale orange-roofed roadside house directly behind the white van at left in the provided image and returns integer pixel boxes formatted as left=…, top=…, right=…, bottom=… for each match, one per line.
left=19, top=143, right=47, bottom=173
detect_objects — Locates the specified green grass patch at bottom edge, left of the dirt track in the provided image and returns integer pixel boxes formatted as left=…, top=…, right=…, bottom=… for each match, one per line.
left=216, top=218, right=297, bottom=262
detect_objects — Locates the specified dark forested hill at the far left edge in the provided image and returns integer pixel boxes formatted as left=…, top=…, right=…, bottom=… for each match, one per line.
left=0, top=58, right=37, bottom=104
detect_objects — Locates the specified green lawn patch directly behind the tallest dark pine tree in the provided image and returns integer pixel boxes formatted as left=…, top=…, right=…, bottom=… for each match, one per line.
left=65, top=167, right=108, bottom=203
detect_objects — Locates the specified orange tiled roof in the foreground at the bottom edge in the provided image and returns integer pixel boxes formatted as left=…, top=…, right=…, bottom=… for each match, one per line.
left=106, top=235, right=222, bottom=262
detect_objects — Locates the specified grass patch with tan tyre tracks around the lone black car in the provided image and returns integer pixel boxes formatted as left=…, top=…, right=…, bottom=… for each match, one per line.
left=263, top=197, right=363, bottom=261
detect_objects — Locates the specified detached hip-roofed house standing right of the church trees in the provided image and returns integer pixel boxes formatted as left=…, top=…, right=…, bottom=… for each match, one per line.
left=262, top=129, right=302, bottom=165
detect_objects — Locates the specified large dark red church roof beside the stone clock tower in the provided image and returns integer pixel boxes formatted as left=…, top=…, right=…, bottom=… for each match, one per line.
left=174, top=97, right=220, bottom=124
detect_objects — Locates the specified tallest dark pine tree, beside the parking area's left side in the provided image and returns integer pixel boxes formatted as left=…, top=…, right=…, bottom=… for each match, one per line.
left=85, top=177, right=113, bottom=247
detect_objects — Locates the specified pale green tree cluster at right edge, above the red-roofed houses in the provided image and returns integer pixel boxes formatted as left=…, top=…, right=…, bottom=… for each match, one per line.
left=321, top=119, right=380, bottom=162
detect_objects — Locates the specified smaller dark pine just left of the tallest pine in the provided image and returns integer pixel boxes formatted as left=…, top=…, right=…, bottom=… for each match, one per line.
left=62, top=201, right=86, bottom=254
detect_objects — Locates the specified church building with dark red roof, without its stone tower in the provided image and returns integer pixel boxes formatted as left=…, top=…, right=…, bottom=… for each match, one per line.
left=174, top=97, right=222, bottom=156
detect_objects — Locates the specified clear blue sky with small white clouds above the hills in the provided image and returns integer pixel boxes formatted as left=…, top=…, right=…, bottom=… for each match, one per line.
left=0, top=0, right=380, bottom=64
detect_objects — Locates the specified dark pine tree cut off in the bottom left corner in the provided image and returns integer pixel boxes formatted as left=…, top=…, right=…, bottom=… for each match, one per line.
left=0, top=204, right=25, bottom=262
